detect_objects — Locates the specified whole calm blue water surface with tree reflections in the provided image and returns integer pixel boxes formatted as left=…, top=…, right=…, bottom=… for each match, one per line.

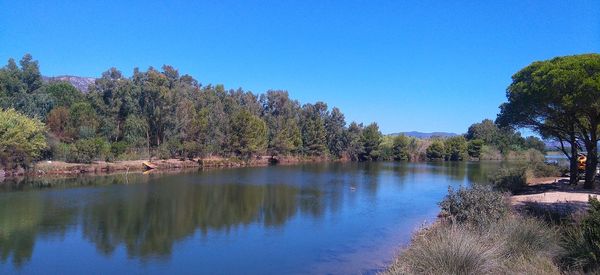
left=0, top=163, right=500, bottom=274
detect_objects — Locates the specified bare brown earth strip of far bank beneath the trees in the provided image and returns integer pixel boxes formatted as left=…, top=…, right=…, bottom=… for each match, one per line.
left=0, top=156, right=332, bottom=182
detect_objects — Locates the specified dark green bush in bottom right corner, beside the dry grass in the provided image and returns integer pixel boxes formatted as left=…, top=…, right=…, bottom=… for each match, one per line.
left=562, top=197, right=600, bottom=272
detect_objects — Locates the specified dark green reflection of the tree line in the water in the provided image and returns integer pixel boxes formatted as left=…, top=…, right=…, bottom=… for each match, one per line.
left=0, top=163, right=506, bottom=267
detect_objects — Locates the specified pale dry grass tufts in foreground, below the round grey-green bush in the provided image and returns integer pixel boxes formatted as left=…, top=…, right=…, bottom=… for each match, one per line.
left=385, top=215, right=561, bottom=274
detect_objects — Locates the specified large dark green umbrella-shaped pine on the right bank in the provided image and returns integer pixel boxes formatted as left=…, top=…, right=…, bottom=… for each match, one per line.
left=497, top=54, right=600, bottom=188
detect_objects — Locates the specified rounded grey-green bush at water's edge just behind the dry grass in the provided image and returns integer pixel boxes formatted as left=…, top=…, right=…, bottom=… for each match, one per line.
left=440, top=185, right=509, bottom=227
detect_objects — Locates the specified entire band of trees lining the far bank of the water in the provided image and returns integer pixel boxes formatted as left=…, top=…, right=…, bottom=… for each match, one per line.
left=0, top=54, right=544, bottom=168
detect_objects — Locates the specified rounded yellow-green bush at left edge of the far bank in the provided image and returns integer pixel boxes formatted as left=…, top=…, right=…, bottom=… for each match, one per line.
left=0, top=109, right=47, bottom=168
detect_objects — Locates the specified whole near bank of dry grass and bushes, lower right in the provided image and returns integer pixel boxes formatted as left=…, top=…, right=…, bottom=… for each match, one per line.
left=384, top=164, right=600, bottom=274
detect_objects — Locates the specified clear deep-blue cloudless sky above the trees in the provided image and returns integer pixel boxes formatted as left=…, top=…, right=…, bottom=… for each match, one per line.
left=0, top=0, right=600, bottom=133
